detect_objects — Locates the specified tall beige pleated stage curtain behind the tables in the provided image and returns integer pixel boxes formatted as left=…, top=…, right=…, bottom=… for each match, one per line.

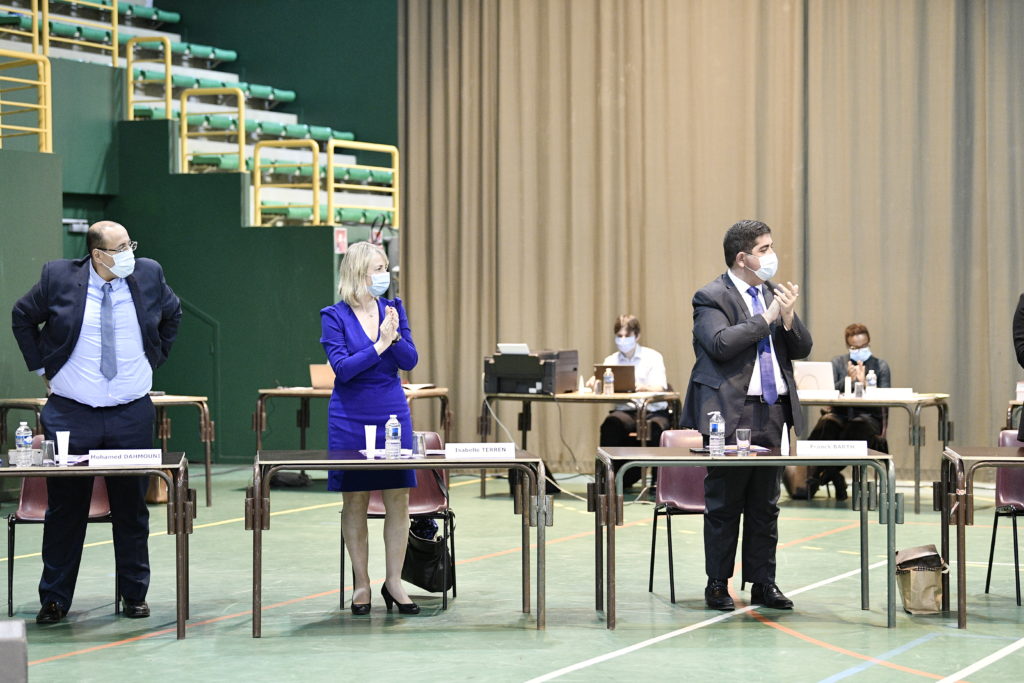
left=399, top=0, right=1022, bottom=479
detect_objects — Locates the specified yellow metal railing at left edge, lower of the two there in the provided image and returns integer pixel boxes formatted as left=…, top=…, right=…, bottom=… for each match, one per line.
left=0, top=50, right=53, bottom=153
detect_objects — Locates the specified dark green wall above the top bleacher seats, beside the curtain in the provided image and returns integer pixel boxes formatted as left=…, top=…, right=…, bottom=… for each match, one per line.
left=157, top=0, right=398, bottom=144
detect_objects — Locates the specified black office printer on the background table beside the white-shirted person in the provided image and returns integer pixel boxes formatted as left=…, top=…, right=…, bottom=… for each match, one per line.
left=483, top=349, right=580, bottom=394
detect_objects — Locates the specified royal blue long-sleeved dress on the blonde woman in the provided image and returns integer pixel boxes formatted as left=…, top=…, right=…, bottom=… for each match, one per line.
left=321, top=298, right=419, bottom=490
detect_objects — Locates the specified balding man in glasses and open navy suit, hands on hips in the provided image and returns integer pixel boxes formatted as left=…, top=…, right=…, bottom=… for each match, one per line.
left=11, top=221, right=181, bottom=624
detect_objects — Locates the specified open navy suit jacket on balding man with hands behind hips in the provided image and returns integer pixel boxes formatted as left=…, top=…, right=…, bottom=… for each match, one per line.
left=11, top=256, right=181, bottom=379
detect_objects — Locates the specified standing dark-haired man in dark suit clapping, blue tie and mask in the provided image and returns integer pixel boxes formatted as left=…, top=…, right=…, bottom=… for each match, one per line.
left=683, top=220, right=811, bottom=610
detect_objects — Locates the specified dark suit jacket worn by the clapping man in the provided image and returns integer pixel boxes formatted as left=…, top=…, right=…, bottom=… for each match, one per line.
left=683, top=273, right=812, bottom=434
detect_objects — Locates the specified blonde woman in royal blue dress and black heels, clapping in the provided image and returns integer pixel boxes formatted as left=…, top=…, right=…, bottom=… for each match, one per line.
left=321, top=242, right=420, bottom=614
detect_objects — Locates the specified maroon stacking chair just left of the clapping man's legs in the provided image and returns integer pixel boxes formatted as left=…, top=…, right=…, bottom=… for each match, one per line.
left=647, top=429, right=708, bottom=602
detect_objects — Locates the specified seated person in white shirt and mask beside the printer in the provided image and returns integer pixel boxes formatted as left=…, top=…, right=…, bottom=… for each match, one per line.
left=588, top=314, right=669, bottom=486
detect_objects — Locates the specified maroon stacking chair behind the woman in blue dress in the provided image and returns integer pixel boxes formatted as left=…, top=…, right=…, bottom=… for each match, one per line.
left=339, top=432, right=457, bottom=609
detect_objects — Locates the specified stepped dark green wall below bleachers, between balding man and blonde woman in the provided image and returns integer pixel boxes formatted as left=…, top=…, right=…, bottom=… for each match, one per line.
left=109, top=121, right=334, bottom=462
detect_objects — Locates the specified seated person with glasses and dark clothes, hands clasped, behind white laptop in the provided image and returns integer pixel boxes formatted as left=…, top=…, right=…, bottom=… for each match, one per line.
left=809, top=323, right=892, bottom=501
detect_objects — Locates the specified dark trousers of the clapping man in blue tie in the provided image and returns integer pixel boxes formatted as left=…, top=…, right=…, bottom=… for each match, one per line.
left=705, top=396, right=793, bottom=584
